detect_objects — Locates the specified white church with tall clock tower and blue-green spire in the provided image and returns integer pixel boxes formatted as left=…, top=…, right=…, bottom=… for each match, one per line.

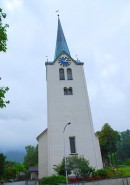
left=37, top=16, right=103, bottom=178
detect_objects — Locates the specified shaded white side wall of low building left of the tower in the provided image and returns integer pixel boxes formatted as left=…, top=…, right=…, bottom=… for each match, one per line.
left=38, top=130, right=48, bottom=179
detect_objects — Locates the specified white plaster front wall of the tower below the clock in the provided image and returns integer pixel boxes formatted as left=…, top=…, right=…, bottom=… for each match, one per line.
left=46, top=53, right=102, bottom=175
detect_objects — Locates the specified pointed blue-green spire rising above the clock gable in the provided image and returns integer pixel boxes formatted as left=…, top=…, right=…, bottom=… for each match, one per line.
left=54, top=15, right=70, bottom=60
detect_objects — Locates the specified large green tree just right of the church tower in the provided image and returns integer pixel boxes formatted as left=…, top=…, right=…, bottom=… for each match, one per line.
left=96, top=123, right=120, bottom=165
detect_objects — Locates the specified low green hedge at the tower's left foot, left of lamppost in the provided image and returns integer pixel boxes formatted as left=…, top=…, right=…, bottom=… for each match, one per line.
left=40, top=175, right=66, bottom=185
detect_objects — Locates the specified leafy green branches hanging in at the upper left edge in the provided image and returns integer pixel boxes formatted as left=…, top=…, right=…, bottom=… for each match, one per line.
left=0, top=8, right=9, bottom=108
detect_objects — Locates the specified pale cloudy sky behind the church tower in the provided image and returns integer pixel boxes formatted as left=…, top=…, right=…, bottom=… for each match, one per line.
left=0, top=0, right=130, bottom=151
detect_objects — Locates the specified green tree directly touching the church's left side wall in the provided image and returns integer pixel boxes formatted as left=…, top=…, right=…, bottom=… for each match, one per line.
left=24, top=145, right=38, bottom=169
